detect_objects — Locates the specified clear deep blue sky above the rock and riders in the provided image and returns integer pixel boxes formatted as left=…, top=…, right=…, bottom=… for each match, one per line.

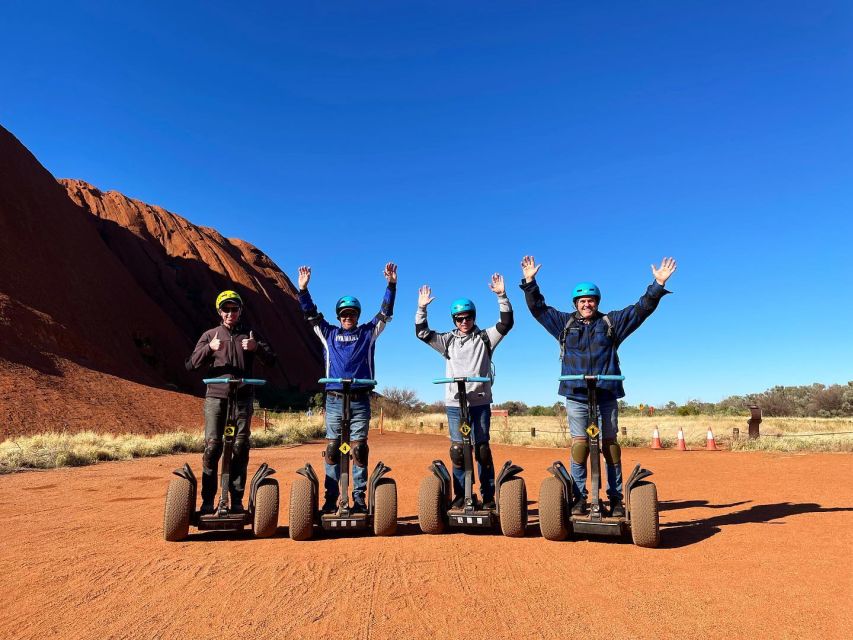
left=0, top=0, right=853, bottom=404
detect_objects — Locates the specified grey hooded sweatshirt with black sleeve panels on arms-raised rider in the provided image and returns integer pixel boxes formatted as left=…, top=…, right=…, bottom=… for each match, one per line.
left=415, top=294, right=514, bottom=407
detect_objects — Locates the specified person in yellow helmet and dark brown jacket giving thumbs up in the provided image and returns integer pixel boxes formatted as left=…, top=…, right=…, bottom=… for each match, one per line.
left=185, top=289, right=276, bottom=515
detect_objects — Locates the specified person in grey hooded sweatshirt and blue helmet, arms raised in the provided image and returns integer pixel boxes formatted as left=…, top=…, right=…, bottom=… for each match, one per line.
left=415, top=273, right=514, bottom=509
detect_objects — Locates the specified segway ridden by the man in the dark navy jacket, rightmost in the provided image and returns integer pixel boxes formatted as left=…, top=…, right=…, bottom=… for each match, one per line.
left=539, top=375, right=660, bottom=547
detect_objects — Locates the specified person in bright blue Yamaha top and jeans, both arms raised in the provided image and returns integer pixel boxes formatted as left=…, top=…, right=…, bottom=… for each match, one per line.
left=299, top=262, right=397, bottom=513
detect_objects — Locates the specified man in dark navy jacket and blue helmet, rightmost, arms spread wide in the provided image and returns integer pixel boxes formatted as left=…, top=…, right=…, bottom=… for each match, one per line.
left=520, top=256, right=676, bottom=518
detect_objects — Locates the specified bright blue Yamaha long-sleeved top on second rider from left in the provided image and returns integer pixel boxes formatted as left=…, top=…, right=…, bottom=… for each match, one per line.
left=299, top=283, right=397, bottom=391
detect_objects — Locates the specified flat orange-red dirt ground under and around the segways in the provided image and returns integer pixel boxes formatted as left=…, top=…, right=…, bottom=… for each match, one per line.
left=0, top=431, right=853, bottom=640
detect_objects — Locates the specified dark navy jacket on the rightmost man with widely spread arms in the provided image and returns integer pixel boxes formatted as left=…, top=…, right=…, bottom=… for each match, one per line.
left=521, top=280, right=670, bottom=402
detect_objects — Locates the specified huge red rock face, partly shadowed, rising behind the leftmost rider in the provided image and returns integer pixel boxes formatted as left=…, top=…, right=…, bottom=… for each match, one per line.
left=0, top=127, right=322, bottom=439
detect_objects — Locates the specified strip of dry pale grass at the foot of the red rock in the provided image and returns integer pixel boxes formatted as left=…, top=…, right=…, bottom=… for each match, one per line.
left=0, top=414, right=323, bottom=473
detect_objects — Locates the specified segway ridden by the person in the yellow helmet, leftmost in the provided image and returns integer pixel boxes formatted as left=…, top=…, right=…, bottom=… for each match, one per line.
left=163, top=378, right=278, bottom=542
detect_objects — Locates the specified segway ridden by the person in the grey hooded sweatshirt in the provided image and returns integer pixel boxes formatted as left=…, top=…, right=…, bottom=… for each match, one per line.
left=418, top=376, right=527, bottom=538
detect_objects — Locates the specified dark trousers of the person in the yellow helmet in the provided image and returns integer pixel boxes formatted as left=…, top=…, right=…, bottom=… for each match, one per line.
left=201, top=398, right=252, bottom=505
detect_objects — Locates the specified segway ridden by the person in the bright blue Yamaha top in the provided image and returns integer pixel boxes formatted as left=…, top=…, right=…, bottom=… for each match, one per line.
left=289, top=378, right=397, bottom=540
